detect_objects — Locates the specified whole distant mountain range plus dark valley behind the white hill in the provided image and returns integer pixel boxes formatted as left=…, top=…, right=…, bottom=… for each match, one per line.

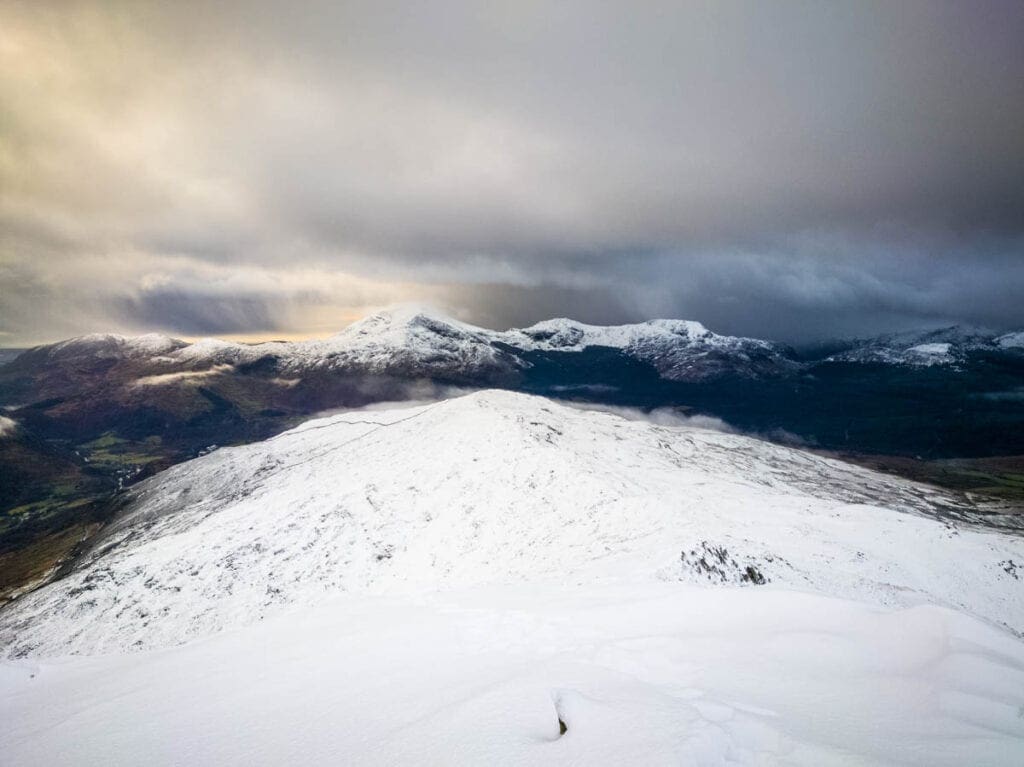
left=0, top=307, right=1024, bottom=594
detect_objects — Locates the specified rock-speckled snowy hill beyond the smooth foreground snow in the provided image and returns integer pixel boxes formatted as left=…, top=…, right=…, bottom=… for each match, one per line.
left=0, top=391, right=1024, bottom=656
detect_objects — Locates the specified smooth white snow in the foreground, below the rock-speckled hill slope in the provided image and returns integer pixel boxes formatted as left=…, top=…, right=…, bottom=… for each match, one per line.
left=0, top=582, right=1024, bottom=767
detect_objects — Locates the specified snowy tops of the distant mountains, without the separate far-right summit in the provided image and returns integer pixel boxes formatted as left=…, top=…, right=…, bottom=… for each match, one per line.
left=2, top=306, right=795, bottom=383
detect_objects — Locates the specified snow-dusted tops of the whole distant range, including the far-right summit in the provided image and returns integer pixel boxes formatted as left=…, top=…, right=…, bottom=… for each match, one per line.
left=20, top=305, right=1024, bottom=385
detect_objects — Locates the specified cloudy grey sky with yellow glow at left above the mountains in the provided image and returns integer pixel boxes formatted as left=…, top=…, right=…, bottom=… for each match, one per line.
left=0, top=0, right=1024, bottom=346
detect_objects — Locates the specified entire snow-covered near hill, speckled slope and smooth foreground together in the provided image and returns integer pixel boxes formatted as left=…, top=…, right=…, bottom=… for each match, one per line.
left=0, top=391, right=1024, bottom=767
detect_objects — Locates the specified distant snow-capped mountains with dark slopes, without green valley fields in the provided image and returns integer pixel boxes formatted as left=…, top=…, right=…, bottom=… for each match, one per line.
left=0, top=307, right=1024, bottom=460
